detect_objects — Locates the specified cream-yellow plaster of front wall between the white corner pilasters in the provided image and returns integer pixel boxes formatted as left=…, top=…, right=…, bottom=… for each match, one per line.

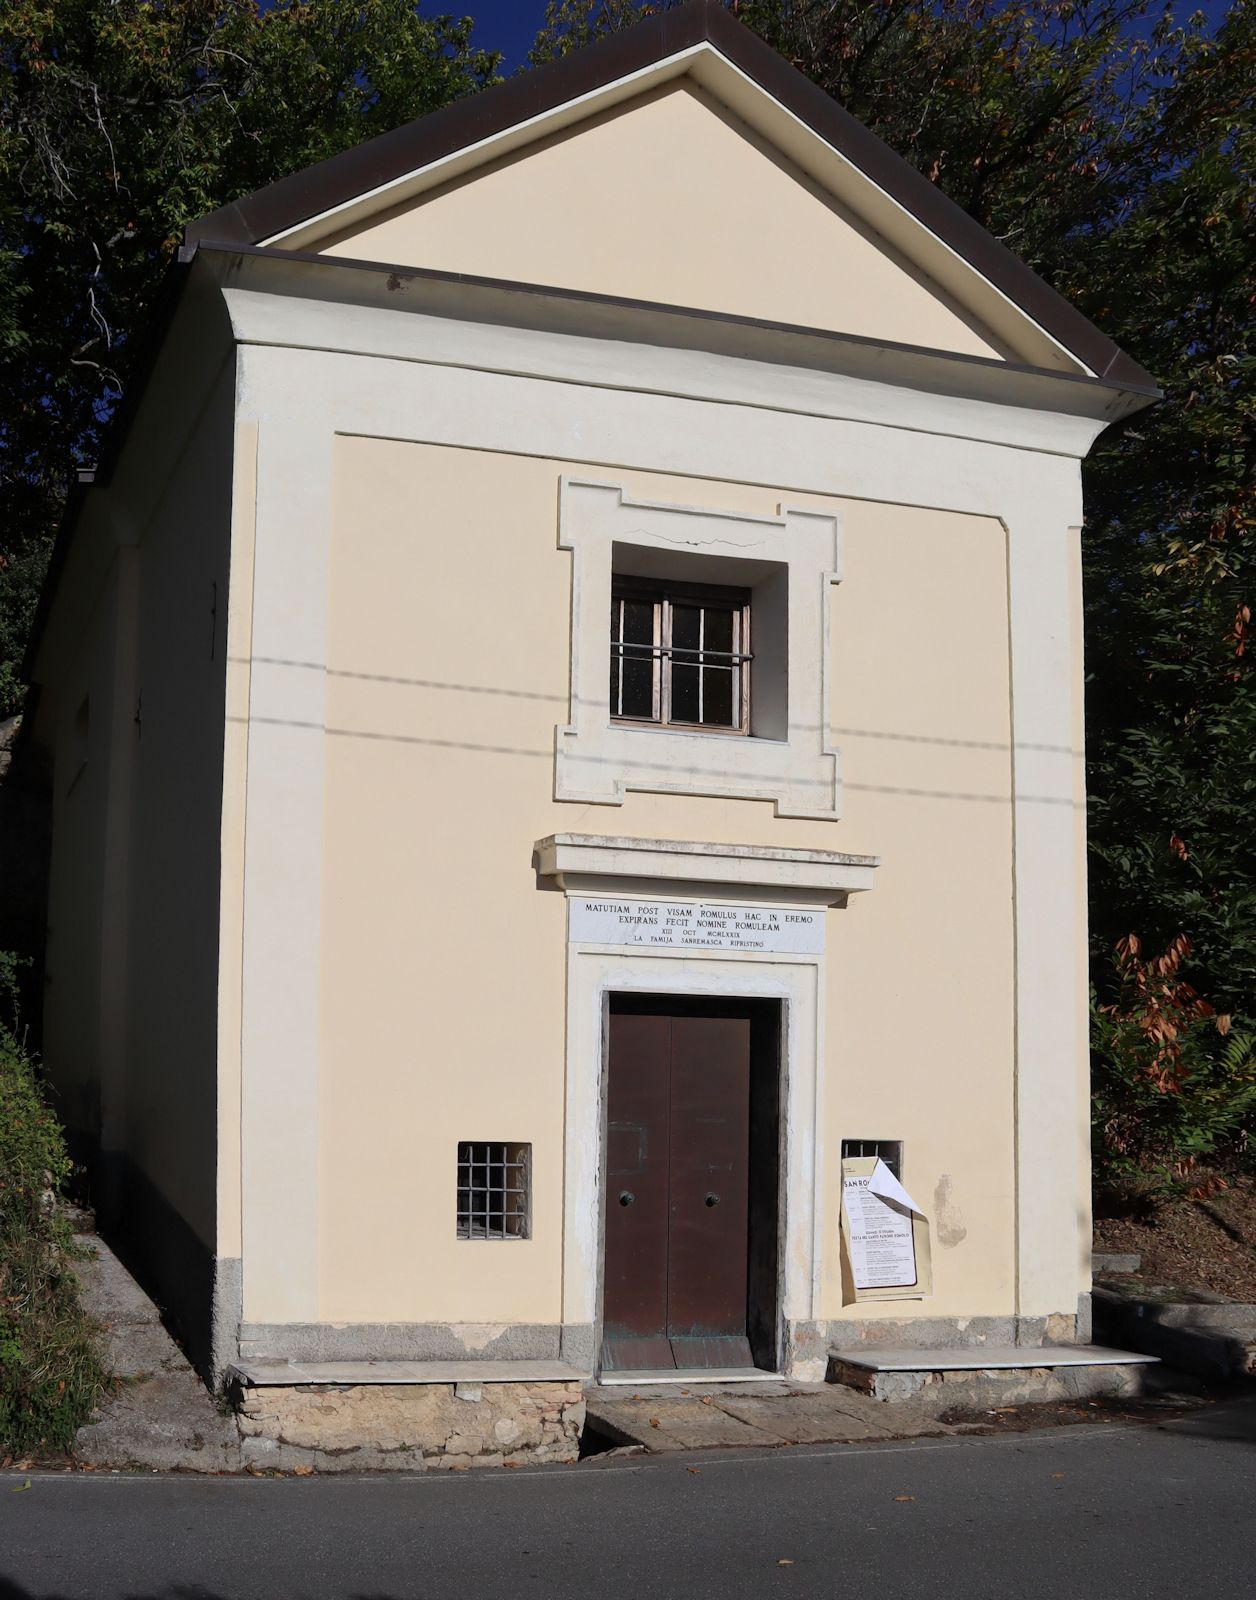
left=316, top=438, right=1017, bottom=1323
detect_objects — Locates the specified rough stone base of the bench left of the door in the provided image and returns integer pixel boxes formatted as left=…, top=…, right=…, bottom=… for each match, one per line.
left=232, top=1382, right=584, bottom=1472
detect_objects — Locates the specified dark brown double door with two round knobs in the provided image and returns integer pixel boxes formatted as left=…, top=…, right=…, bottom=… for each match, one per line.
left=602, top=1005, right=754, bottom=1370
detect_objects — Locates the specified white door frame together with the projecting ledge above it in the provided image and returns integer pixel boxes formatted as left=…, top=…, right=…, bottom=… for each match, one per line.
left=533, top=834, right=877, bottom=1378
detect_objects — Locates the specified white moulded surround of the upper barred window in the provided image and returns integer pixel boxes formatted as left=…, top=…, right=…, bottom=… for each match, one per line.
left=554, top=477, right=842, bottom=821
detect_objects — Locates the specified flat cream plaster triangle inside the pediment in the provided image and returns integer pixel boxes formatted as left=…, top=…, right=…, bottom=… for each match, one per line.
left=306, top=80, right=1008, bottom=366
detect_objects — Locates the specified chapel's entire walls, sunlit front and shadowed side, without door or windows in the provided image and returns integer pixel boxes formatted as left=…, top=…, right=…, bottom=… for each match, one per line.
left=35, top=12, right=1142, bottom=1376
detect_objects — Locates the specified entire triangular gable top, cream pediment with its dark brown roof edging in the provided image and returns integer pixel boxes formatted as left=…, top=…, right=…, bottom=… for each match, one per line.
left=184, top=0, right=1155, bottom=395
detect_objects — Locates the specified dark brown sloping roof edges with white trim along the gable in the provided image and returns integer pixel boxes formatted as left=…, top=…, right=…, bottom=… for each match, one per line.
left=184, top=0, right=1155, bottom=390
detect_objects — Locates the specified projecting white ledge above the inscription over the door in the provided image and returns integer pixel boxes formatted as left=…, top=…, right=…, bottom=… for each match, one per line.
left=533, top=834, right=880, bottom=906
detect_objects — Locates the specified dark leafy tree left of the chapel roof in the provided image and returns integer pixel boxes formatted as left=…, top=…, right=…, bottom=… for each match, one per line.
left=0, top=0, right=499, bottom=717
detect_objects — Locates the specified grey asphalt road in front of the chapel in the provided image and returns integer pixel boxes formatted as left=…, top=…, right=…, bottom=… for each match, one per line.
left=0, top=1402, right=1256, bottom=1600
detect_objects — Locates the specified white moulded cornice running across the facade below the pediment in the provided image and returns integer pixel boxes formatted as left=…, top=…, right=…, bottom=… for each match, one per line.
left=218, top=268, right=1147, bottom=459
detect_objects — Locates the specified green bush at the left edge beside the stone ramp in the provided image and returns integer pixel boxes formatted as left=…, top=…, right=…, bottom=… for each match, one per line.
left=0, top=1004, right=107, bottom=1456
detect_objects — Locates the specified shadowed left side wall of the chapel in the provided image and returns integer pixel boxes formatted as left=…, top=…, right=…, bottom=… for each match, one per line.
left=43, top=362, right=234, bottom=1360
